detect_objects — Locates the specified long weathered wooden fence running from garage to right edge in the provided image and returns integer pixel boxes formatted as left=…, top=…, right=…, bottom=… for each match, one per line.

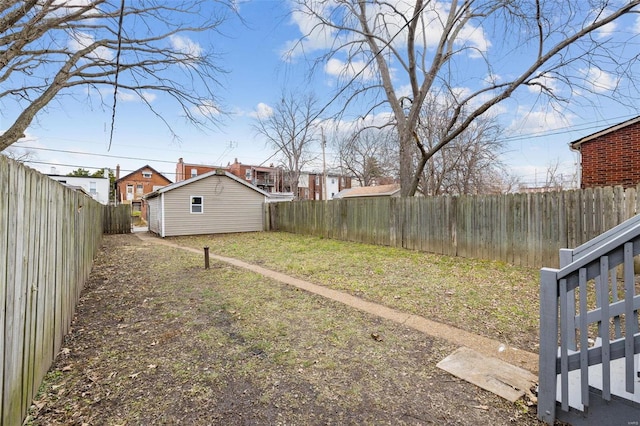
left=266, top=187, right=640, bottom=268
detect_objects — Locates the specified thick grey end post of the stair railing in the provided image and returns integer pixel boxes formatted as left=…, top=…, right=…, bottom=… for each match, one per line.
left=538, top=268, right=558, bottom=424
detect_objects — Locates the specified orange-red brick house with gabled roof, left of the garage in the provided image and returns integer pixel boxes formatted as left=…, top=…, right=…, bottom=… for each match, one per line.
left=116, top=165, right=171, bottom=218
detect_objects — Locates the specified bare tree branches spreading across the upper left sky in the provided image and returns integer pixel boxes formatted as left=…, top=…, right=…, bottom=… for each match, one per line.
left=0, top=0, right=233, bottom=150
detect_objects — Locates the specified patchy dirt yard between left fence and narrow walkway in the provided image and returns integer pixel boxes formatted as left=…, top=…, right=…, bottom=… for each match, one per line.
left=27, top=235, right=538, bottom=425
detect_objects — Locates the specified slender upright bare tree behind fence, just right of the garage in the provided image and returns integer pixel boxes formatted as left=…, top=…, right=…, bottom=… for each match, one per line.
left=254, top=92, right=319, bottom=198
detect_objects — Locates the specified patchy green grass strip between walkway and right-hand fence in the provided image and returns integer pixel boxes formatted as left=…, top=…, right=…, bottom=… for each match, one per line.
left=171, top=232, right=539, bottom=352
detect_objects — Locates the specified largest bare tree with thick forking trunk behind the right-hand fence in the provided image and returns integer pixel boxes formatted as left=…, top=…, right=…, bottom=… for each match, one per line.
left=290, top=0, right=640, bottom=196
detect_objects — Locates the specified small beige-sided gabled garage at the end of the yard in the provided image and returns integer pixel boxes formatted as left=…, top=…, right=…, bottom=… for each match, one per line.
left=145, top=169, right=269, bottom=237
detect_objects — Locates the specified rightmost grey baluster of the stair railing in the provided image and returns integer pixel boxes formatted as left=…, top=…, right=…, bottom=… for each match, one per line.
left=624, top=243, right=638, bottom=393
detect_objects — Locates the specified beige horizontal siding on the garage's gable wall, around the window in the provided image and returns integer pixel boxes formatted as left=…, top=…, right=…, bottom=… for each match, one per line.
left=164, top=175, right=264, bottom=237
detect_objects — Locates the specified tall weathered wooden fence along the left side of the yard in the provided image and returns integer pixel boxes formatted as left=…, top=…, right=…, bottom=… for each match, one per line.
left=0, top=155, right=104, bottom=425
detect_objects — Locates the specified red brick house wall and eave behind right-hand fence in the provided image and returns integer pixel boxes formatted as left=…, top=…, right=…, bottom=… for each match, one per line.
left=569, top=116, right=640, bottom=188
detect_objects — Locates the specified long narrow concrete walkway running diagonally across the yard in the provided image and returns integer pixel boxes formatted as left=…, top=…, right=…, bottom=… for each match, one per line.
left=136, top=233, right=538, bottom=374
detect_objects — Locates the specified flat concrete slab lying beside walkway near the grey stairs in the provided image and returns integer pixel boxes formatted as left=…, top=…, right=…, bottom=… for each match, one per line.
left=437, top=347, right=538, bottom=402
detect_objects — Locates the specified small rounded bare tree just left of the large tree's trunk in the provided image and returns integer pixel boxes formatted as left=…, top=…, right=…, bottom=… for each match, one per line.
left=334, top=128, right=398, bottom=186
